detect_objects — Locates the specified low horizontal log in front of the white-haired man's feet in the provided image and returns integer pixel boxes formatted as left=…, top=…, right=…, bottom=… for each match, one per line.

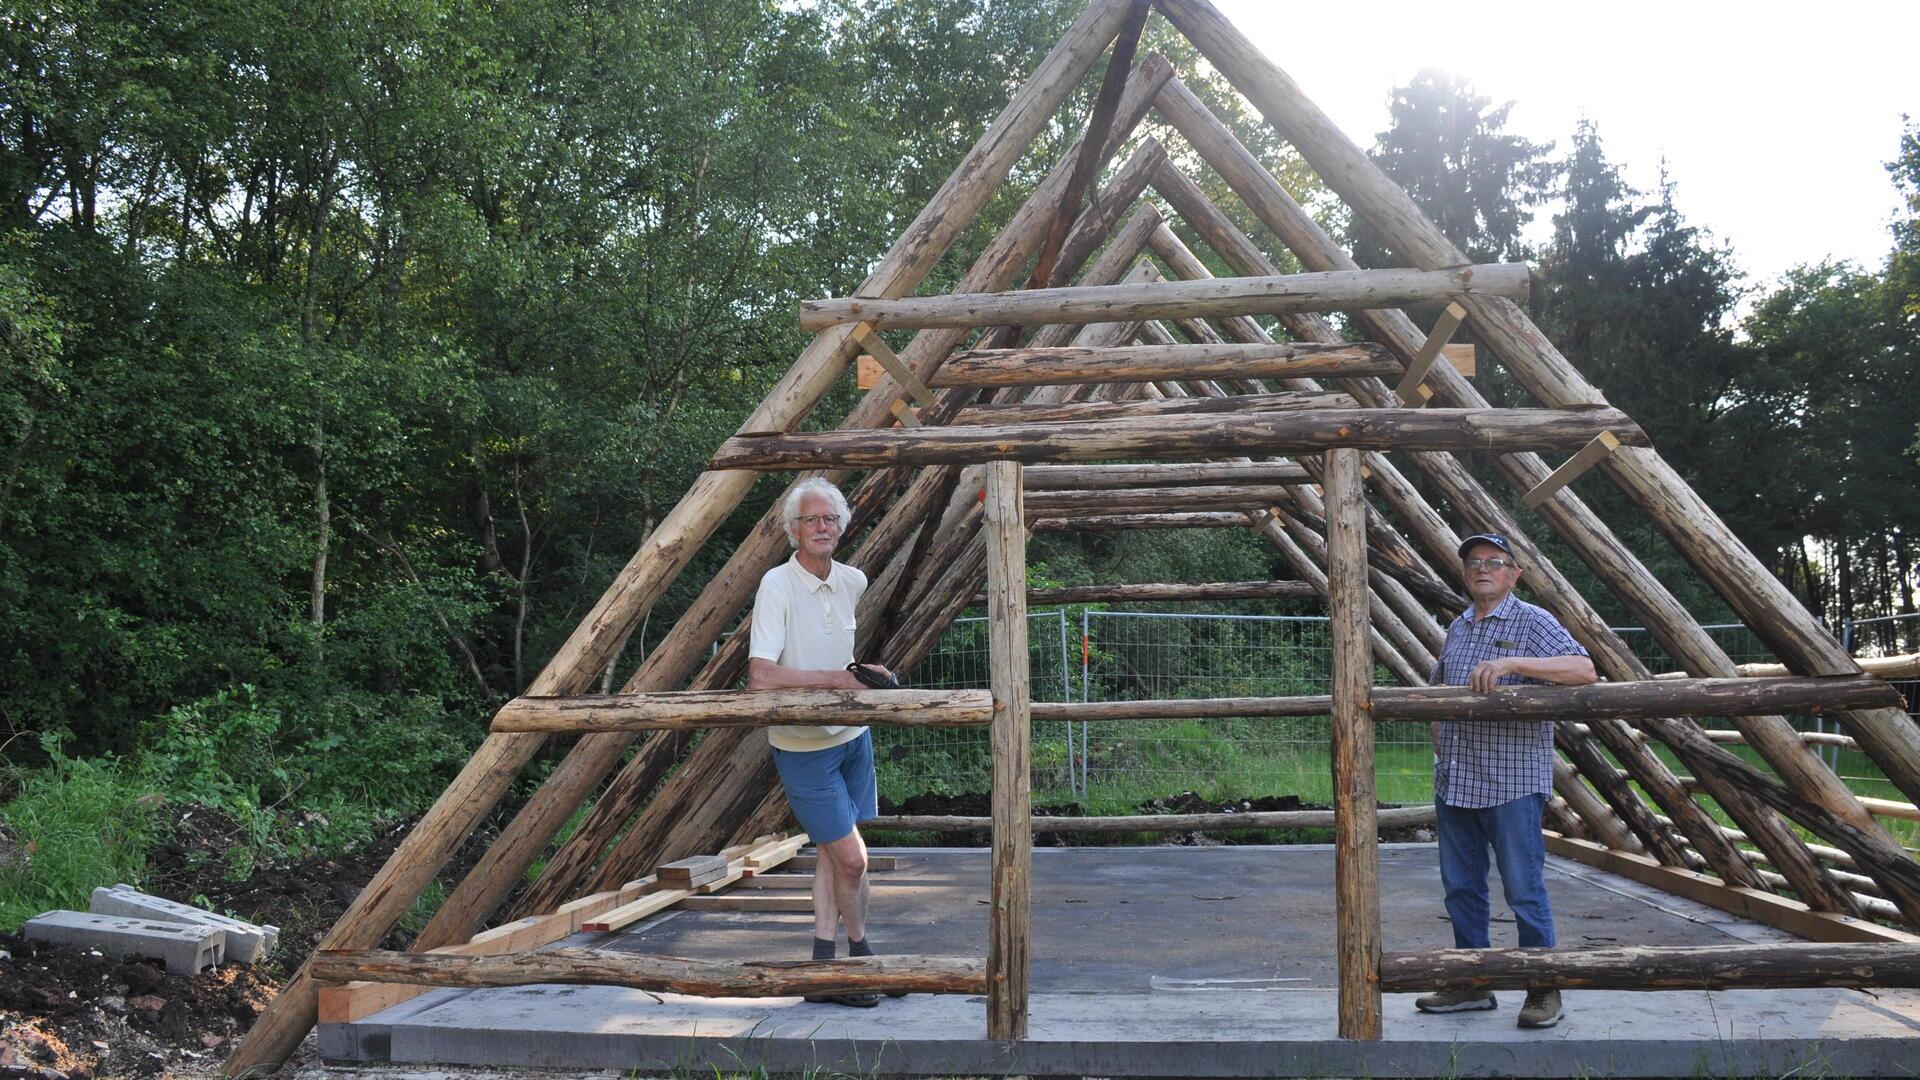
left=313, top=949, right=987, bottom=997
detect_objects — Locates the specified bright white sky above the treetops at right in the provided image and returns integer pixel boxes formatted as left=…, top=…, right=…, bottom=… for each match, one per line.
left=1213, top=0, right=1920, bottom=284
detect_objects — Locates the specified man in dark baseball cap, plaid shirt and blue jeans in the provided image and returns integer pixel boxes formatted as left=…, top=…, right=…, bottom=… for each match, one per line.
left=1413, top=532, right=1596, bottom=1028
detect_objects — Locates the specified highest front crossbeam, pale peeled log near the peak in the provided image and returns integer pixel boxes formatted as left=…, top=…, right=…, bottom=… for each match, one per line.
left=801, top=263, right=1530, bottom=334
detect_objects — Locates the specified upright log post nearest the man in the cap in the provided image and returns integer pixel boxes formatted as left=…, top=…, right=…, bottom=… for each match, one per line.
left=1325, top=450, right=1380, bottom=1040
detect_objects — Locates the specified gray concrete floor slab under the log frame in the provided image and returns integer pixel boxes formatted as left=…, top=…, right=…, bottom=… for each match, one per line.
left=319, top=844, right=1920, bottom=1076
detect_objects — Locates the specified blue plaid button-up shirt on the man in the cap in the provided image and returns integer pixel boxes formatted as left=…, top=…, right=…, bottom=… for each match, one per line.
left=1428, top=594, right=1588, bottom=809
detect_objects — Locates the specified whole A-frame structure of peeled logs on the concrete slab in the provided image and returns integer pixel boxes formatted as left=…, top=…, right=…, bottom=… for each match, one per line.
left=227, top=0, right=1920, bottom=1074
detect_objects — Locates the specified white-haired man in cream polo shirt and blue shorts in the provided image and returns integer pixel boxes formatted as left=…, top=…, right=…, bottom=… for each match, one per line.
left=747, top=479, right=891, bottom=1009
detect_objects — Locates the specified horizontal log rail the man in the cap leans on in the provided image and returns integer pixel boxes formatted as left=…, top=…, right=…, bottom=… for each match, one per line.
left=1373, top=675, right=1899, bottom=721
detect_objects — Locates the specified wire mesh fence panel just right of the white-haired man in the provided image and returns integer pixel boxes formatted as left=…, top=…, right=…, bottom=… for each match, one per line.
left=874, top=611, right=1077, bottom=801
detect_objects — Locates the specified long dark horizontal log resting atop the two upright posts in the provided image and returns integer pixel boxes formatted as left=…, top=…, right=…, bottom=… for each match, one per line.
left=708, top=409, right=1647, bottom=471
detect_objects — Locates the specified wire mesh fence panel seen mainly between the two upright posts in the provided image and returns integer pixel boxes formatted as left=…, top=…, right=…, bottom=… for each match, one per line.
left=1081, top=611, right=1432, bottom=807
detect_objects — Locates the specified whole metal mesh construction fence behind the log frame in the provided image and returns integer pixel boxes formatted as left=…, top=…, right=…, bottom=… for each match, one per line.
left=874, top=607, right=1920, bottom=805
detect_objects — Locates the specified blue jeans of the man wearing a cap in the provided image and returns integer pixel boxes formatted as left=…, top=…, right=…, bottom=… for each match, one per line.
left=1434, top=794, right=1553, bottom=949
